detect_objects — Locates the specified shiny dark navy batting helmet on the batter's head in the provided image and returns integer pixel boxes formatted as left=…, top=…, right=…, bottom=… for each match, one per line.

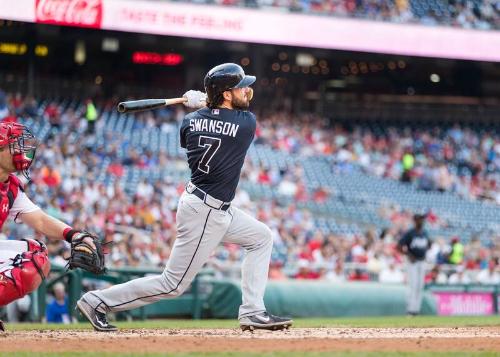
left=204, top=63, right=255, bottom=107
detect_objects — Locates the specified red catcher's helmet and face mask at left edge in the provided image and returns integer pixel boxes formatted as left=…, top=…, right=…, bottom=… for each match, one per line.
left=0, top=123, right=38, bottom=180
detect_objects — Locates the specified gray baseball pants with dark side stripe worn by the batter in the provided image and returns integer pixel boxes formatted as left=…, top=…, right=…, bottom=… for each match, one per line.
left=83, top=192, right=273, bottom=318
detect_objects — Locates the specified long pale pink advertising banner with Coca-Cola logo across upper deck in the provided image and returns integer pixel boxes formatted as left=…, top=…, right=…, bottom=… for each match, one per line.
left=0, top=0, right=500, bottom=62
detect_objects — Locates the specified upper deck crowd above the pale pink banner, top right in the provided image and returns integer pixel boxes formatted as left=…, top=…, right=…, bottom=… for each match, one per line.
left=177, top=0, right=500, bottom=30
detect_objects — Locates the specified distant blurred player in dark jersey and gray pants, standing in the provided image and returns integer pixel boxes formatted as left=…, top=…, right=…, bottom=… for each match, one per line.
left=398, top=214, right=432, bottom=316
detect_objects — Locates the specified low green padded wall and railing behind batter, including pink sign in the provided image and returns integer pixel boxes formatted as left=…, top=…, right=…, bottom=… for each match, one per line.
left=32, top=267, right=500, bottom=321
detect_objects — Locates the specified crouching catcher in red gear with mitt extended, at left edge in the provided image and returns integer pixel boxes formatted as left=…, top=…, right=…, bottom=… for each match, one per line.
left=0, top=123, right=104, bottom=331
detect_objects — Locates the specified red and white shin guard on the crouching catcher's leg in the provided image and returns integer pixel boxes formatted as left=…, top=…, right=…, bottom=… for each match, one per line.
left=0, top=251, right=50, bottom=306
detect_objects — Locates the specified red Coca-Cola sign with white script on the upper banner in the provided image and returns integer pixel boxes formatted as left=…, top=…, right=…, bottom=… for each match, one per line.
left=35, top=0, right=103, bottom=28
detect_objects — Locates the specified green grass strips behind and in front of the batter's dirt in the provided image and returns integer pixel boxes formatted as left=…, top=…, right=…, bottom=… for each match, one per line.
left=0, top=316, right=500, bottom=357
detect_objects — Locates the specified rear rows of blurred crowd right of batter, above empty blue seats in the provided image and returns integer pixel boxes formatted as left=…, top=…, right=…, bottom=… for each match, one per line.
left=256, top=113, right=500, bottom=204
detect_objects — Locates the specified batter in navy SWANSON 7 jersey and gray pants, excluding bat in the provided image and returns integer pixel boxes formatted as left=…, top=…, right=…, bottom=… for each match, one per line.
left=77, top=63, right=292, bottom=331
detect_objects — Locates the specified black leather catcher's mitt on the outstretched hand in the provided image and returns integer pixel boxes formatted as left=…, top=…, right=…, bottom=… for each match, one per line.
left=68, top=231, right=106, bottom=275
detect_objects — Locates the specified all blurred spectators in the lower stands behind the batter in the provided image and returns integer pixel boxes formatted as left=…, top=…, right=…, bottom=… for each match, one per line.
left=0, top=93, right=500, bottom=283
